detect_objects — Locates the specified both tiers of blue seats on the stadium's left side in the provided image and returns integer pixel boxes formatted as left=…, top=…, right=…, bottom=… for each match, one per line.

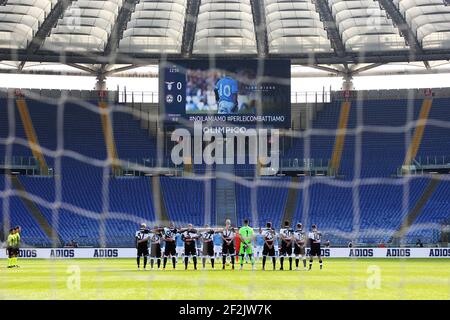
left=0, top=100, right=160, bottom=246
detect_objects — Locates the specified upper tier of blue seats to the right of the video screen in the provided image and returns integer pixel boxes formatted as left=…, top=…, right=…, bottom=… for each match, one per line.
left=284, top=98, right=449, bottom=179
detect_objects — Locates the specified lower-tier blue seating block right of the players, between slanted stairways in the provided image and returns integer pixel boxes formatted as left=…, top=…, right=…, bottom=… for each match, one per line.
left=288, top=178, right=436, bottom=245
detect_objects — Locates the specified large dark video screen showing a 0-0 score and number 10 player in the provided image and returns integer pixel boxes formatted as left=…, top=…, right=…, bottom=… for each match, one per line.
left=160, top=60, right=291, bottom=127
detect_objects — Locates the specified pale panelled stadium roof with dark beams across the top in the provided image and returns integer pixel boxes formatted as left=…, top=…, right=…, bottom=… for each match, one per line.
left=0, top=0, right=450, bottom=76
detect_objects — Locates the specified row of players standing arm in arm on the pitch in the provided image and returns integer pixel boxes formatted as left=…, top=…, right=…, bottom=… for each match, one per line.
left=135, top=220, right=323, bottom=270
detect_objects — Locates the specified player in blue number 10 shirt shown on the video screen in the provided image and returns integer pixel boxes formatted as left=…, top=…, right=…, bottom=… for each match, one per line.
left=214, top=76, right=239, bottom=114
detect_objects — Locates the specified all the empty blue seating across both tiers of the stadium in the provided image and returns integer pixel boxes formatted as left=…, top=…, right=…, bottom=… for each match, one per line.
left=0, top=99, right=450, bottom=246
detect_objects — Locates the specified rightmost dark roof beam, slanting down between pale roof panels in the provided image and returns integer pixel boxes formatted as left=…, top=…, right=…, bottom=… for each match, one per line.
left=378, top=0, right=430, bottom=69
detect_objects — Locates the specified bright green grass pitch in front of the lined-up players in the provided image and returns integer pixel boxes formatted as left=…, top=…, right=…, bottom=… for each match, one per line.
left=0, top=259, right=450, bottom=300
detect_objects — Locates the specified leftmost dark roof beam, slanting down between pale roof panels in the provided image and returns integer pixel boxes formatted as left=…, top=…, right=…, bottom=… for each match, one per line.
left=19, top=0, right=73, bottom=70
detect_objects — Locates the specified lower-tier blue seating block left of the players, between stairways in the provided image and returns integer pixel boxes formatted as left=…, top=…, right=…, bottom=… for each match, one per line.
left=21, top=168, right=155, bottom=247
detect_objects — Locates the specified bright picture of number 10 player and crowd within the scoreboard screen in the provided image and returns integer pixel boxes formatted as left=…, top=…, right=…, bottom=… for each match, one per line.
left=186, top=69, right=256, bottom=114
